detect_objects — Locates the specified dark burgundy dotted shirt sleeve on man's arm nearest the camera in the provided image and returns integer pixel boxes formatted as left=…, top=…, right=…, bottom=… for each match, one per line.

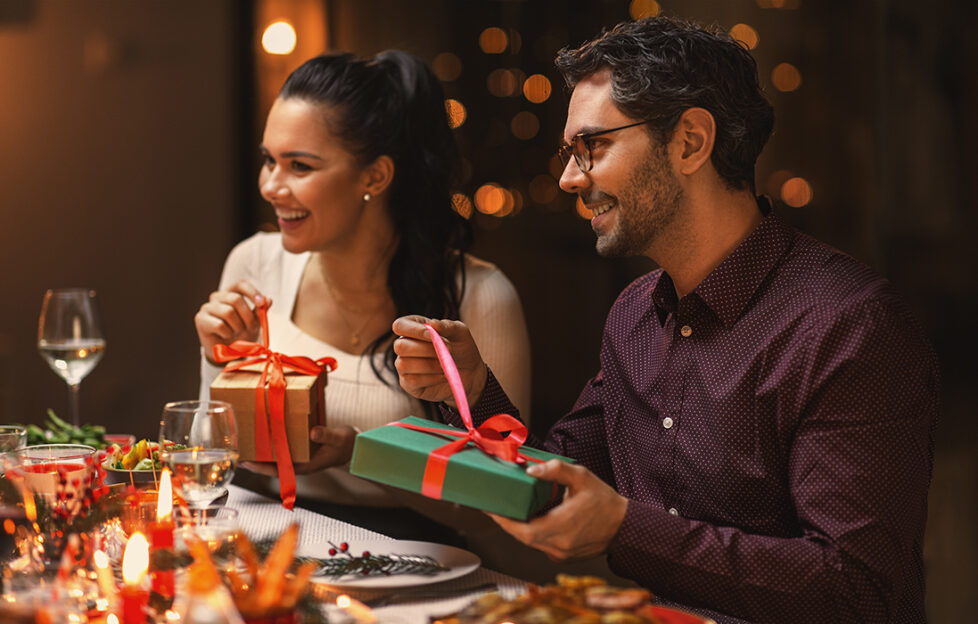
left=609, top=302, right=939, bottom=623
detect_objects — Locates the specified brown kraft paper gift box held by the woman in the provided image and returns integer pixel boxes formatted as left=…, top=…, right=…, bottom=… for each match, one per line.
left=211, top=363, right=326, bottom=462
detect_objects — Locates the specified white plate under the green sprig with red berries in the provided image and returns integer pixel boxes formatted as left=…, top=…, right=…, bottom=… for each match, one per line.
left=296, top=540, right=482, bottom=589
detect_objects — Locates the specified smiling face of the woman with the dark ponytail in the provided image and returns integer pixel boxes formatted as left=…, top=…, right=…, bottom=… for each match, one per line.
left=258, top=98, right=367, bottom=253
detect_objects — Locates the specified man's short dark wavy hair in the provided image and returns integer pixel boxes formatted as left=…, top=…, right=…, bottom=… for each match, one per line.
left=556, top=17, right=774, bottom=192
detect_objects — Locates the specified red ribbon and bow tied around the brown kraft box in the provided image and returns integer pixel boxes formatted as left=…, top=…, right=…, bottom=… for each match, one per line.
left=214, top=304, right=336, bottom=509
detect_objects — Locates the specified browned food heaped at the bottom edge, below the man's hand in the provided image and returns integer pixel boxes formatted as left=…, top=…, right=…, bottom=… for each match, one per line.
left=441, top=574, right=663, bottom=624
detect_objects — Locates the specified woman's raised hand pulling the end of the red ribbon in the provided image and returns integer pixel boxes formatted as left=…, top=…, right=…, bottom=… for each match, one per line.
left=194, top=280, right=272, bottom=363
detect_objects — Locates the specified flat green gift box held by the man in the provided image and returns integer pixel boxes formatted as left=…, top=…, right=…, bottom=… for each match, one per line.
left=350, top=416, right=574, bottom=520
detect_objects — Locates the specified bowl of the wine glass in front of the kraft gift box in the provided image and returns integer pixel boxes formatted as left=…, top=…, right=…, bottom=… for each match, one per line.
left=160, top=401, right=238, bottom=507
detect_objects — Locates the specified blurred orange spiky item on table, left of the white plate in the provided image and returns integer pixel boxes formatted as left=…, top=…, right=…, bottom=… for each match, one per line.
left=226, top=522, right=316, bottom=619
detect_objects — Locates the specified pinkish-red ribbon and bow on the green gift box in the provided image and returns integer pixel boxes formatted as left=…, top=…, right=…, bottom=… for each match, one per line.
left=391, top=323, right=543, bottom=499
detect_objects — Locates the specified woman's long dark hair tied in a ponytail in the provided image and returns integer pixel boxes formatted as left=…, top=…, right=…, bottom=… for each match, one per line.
left=279, top=50, right=472, bottom=383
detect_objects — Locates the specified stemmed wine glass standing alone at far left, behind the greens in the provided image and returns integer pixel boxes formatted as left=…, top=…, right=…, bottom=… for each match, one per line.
left=37, top=288, right=105, bottom=427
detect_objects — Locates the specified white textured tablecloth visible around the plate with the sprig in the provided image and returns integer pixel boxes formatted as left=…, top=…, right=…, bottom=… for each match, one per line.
left=227, top=486, right=526, bottom=624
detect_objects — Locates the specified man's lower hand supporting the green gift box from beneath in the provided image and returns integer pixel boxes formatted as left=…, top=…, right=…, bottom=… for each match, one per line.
left=489, top=459, right=628, bottom=561
